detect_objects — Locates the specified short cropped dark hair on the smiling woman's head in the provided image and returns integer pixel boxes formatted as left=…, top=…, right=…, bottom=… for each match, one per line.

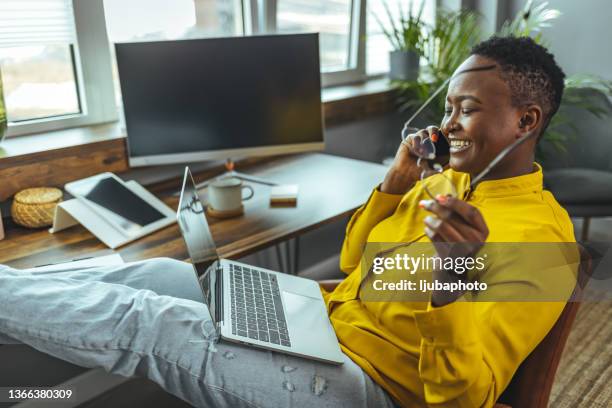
left=471, top=36, right=565, bottom=135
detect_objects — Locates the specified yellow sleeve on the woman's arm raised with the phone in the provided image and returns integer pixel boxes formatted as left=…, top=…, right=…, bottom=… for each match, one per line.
left=340, top=187, right=403, bottom=274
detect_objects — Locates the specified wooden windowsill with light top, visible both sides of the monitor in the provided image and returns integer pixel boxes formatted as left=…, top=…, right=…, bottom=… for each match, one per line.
left=0, top=78, right=395, bottom=201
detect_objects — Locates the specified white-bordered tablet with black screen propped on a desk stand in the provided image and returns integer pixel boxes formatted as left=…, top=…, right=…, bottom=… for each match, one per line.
left=65, top=173, right=173, bottom=236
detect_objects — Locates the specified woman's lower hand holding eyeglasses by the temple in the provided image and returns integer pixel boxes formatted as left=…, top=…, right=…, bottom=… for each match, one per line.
left=419, top=196, right=489, bottom=306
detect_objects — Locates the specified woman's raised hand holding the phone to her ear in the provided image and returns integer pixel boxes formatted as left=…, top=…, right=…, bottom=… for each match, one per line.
left=380, top=126, right=439, bottom=194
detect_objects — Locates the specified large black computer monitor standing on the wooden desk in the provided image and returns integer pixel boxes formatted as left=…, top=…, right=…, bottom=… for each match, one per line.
left=115, top=34, right=324, bottom=166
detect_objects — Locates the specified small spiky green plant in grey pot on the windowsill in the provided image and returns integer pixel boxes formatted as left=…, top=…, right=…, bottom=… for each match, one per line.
left=372, top=0, right=426, bottom=81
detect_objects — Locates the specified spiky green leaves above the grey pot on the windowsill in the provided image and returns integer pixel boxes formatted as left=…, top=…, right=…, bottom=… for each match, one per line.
left=371, top=0, right=427, bottom=55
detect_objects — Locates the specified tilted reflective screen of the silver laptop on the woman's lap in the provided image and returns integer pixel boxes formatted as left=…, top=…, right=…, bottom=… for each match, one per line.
left=176, top=167, right=222, bottom=323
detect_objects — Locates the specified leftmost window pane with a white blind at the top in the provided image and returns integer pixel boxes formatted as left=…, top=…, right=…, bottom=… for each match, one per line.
left=0, top=0, right=81, bottom=122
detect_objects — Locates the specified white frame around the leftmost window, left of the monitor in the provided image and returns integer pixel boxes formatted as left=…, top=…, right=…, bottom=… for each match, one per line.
left=7, top=0, right=118, bottom=138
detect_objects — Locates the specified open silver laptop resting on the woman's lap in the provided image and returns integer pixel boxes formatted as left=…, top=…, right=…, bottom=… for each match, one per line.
left=177, top=167, right=344, bottom=364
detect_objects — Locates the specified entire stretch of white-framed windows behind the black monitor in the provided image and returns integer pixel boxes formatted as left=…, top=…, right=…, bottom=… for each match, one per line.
left=0, top=0, right=435, bottom=136
